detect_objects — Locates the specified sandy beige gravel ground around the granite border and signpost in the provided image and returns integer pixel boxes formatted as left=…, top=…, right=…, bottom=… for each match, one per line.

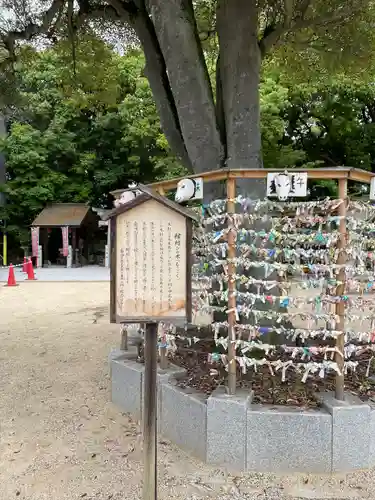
left=0, top=282, right=375, bottom=500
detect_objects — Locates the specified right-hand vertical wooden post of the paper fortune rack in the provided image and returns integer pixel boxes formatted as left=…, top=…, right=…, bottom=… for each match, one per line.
left=335, top=179, right=348, bottom=401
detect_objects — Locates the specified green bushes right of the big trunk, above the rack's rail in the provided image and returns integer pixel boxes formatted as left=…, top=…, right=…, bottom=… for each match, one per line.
left=261, top=64, right=375, bottom=196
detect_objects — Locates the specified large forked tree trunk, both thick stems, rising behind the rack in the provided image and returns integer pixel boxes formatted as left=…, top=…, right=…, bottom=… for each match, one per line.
left=133, top=0, right=266, bottom=197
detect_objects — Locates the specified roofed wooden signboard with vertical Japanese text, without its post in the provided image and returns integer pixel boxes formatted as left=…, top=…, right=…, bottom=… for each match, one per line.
left=110, top=186, right=195, bottom=323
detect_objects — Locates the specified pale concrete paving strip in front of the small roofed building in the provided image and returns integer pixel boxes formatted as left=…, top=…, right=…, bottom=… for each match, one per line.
left=0, top=266, right=109, bottom=283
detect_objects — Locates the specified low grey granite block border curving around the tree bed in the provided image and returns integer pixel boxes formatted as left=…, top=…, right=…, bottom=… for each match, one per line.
left=109, top=351, right=375, bottom=474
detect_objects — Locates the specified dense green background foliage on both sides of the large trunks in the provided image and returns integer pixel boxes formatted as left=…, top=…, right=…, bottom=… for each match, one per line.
left=0, top=19, right=375, bottom=248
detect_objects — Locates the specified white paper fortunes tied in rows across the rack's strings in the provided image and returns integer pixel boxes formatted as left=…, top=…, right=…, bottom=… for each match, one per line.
left=159, top=193, right=375, bottom=382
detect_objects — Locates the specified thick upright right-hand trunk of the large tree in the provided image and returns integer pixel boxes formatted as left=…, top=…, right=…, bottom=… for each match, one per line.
left=217, top=0, right=265, bottom=197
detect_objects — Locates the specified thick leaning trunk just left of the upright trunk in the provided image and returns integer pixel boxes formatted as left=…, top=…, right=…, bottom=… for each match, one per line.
left=149, top=0, right=224, bottom=172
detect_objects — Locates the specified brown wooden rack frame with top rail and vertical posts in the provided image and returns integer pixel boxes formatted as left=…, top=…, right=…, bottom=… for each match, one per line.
left=111, top=167, right=375, bottom=400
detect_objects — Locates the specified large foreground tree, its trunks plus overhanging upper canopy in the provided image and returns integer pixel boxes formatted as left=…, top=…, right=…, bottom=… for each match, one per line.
left=1, top=0, right=373, bottom=180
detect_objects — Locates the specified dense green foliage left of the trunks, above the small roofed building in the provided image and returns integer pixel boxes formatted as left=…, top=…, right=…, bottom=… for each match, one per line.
left=0, top=36, right=184, bottom=244
